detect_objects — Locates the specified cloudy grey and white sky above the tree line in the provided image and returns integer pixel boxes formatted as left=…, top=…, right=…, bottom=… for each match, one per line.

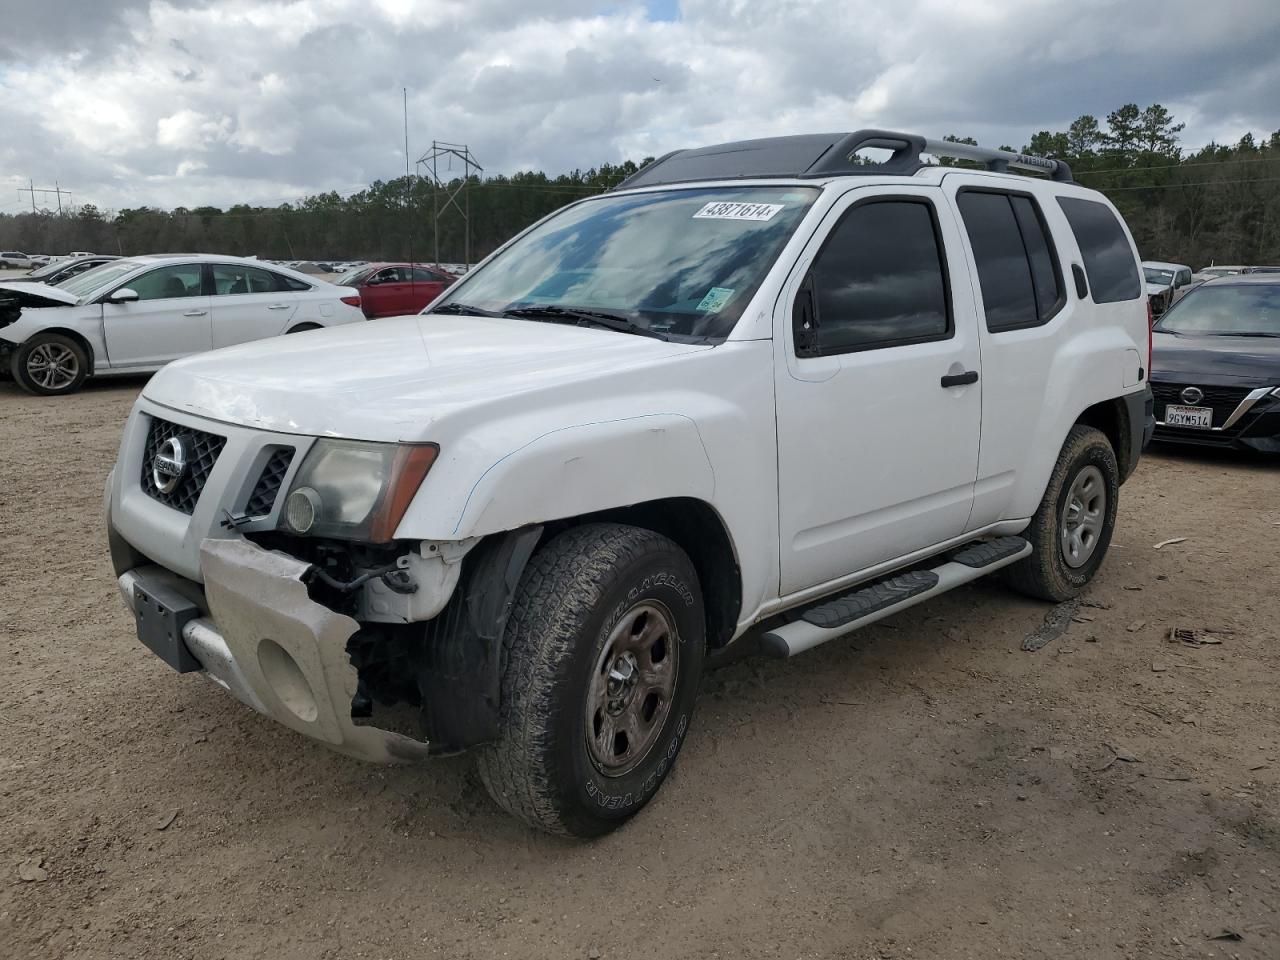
left=0, top=0, right=1280, bottom=211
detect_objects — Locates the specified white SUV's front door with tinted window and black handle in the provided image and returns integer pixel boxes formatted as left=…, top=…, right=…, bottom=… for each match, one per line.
left=774, top=187, right=982, bottom=595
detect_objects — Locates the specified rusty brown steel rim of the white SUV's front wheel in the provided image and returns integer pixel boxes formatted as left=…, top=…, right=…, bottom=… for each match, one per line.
left=585, top=600, right=680, bottom=777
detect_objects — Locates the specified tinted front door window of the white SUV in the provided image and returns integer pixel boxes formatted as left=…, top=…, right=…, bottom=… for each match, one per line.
left=796, top=200, right=951, bottom=356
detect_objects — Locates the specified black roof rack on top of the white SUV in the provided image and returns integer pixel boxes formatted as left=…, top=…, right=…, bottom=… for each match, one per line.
left=616, top=129, right=1071, bottom=189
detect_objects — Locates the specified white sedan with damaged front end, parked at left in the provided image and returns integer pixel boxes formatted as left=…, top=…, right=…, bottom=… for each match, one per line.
left=0, top=253, right=365, bottom=396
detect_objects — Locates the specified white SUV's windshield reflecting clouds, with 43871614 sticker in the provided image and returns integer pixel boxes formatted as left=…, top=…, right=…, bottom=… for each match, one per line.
left=431, top=187, right=818, bottom=339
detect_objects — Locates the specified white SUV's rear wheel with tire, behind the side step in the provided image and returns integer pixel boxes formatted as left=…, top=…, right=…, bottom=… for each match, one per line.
left=1005, top=424, right=1120, bottom=602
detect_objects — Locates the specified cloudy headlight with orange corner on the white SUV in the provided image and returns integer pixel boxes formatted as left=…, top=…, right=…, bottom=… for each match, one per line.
left=280, top=440, right=440, bottom=543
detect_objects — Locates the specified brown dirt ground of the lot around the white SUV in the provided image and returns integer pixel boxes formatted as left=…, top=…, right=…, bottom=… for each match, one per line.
left=0, top=381, right=1280, bottom=960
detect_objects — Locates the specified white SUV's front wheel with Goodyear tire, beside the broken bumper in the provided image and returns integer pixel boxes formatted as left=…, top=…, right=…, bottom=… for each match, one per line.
left=477, top=524, right=705, bottom=837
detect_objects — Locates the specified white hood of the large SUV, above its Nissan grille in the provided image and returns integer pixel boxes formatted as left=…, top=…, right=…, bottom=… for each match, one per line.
left=143, top=315, right=710, bottom=440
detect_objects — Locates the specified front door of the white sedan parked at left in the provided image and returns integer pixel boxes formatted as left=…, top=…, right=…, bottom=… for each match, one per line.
left=102, top=264, right=212, bottom=367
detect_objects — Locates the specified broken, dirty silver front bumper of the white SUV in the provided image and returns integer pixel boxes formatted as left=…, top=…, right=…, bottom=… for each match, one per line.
left=119, top=539, right=429, bottom=763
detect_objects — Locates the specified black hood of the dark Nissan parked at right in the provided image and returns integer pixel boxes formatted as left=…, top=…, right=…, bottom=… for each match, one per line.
left=1151, top=330, right=1280, bottom=387
